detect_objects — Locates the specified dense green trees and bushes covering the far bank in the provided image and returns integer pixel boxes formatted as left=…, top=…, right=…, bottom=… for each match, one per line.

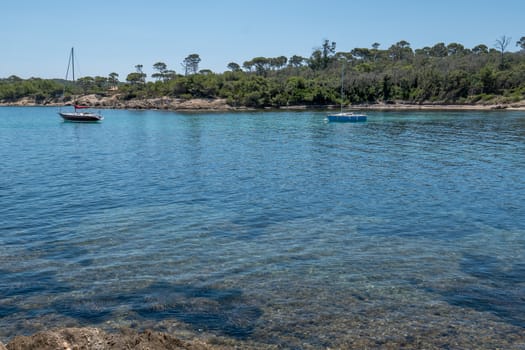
left=0, top=36, right=525, bottom=107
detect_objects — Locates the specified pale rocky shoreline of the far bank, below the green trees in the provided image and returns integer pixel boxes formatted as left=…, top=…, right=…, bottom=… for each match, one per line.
left=0, top=94, right=525, bottom=111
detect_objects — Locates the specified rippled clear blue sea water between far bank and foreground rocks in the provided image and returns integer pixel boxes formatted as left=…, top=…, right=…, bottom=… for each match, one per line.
left=0, top=107, right=525, bottom=349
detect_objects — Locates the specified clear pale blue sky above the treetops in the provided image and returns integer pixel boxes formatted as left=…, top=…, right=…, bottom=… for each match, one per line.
left=4, top=0, right=525, bottom=80
